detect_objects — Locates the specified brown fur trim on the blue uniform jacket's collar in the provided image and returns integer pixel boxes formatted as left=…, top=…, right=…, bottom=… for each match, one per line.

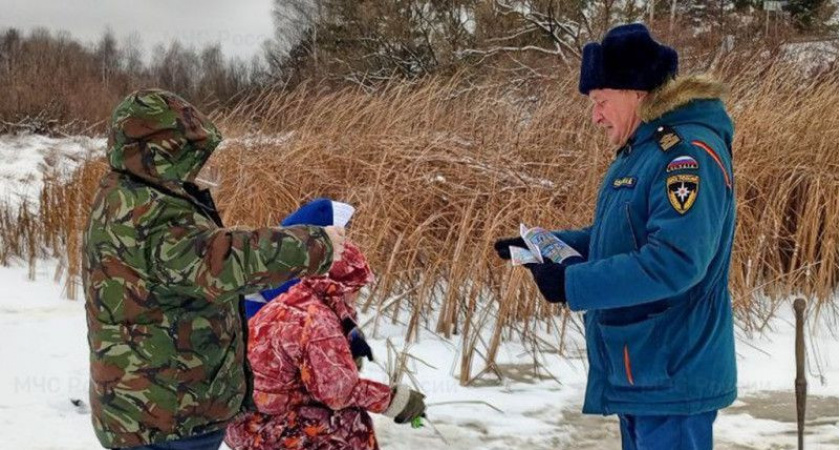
left=639, top=75, right=728, bottom=122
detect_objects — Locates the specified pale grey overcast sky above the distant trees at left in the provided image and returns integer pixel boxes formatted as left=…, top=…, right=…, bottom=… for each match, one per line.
left=0, top=0, right=273, bottom=59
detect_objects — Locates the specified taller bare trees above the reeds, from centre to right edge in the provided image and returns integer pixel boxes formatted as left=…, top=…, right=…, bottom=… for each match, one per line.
left=266, top=0, right=837, bottom=87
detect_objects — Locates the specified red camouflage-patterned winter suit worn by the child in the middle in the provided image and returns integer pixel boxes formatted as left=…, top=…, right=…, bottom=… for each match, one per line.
left=225, top=243, right=391, bottom=450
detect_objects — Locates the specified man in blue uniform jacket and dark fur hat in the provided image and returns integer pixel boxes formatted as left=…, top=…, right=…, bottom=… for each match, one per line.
left=495, top=24, right=737, bottom=450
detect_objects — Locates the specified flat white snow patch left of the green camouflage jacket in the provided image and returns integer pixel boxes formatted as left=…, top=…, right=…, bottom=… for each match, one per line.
left=0, top=263, right=98, bottom=450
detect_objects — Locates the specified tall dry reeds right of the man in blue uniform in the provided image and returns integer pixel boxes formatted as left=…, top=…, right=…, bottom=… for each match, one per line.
left=721, top=53, right=840, bottom=327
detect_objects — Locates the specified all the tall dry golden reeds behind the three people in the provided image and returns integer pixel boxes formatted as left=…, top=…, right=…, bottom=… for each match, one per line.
left=0, top=51, right=838, bottom=384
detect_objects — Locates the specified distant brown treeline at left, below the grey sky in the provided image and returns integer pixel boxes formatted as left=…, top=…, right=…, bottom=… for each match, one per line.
left=0, top=28, right=265, bottom=134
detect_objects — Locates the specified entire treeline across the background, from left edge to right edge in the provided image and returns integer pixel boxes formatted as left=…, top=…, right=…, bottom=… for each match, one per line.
left=0, top=0, right=837, bottom=134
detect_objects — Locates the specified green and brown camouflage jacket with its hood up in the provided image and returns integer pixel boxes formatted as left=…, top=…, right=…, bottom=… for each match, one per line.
left=83, top=90, right=332, bottom=448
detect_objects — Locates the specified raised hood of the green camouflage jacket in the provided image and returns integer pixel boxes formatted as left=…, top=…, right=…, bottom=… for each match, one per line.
left=108, top=89, right=222, bottom=190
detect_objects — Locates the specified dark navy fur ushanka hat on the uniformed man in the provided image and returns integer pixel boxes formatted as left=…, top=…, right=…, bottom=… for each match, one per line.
left=579, top=23, right=678, bottom=95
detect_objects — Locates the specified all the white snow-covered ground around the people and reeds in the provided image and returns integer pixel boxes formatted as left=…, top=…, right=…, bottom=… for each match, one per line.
left=0, top=137, right=839, bottom=450
